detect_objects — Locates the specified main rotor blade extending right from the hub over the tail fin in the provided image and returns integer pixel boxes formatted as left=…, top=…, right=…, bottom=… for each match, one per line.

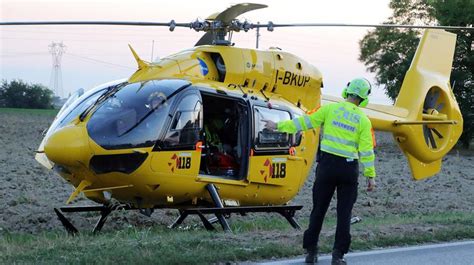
left=251, top=22, right=474, bottom=31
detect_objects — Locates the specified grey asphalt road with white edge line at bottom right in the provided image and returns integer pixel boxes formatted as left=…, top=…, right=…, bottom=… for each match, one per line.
left=260, top=241, right=474, bottom=265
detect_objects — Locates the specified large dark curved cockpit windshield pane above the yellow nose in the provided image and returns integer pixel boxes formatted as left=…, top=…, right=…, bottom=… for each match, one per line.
left=87, top=80, right=190, bottom=149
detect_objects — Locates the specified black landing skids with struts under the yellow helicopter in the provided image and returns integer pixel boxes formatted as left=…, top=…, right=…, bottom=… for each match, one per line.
left=54, top=184, right=303, bottom=235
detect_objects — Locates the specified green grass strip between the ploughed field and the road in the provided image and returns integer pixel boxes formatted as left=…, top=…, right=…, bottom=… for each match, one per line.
left=0, top=212, right=474, bottom=264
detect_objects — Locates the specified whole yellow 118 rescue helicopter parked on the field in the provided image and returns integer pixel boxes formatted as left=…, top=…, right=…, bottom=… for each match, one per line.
left=0, top=4, right=465, bottom=233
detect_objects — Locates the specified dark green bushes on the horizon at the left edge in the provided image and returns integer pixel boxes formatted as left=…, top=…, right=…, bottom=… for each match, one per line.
left=0, top=80, right=54, bottom=109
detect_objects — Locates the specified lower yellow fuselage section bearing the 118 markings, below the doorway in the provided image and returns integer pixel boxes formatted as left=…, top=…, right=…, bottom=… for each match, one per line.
left=79, top=116, right=318, bottom=205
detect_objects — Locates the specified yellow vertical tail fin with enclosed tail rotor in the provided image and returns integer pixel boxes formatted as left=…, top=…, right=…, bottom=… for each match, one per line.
left=393, top=30, right=463, bottom=179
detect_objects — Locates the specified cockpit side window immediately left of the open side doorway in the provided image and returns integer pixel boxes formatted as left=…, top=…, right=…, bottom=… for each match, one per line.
left=161, top=93, right=202, bottom=149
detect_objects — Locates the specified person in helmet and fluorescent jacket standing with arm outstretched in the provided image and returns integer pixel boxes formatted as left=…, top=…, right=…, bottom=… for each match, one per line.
left=266, top=78, right=376, bottom=264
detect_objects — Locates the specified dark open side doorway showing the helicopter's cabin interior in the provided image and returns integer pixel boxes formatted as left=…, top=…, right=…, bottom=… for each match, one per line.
left=201, top=95, right=242, bottom=179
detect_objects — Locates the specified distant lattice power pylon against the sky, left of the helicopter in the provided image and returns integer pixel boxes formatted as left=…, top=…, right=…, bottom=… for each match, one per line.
left=48, top=42, right=66, bottom=98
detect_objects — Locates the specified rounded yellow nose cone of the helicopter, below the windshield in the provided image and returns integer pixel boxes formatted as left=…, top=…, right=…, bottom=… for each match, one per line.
left=44, top=126, right=91, bottom=166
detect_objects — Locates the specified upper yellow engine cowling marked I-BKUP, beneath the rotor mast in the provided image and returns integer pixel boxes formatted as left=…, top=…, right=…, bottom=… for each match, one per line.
left=129, top=46, right=322, bottom=110
